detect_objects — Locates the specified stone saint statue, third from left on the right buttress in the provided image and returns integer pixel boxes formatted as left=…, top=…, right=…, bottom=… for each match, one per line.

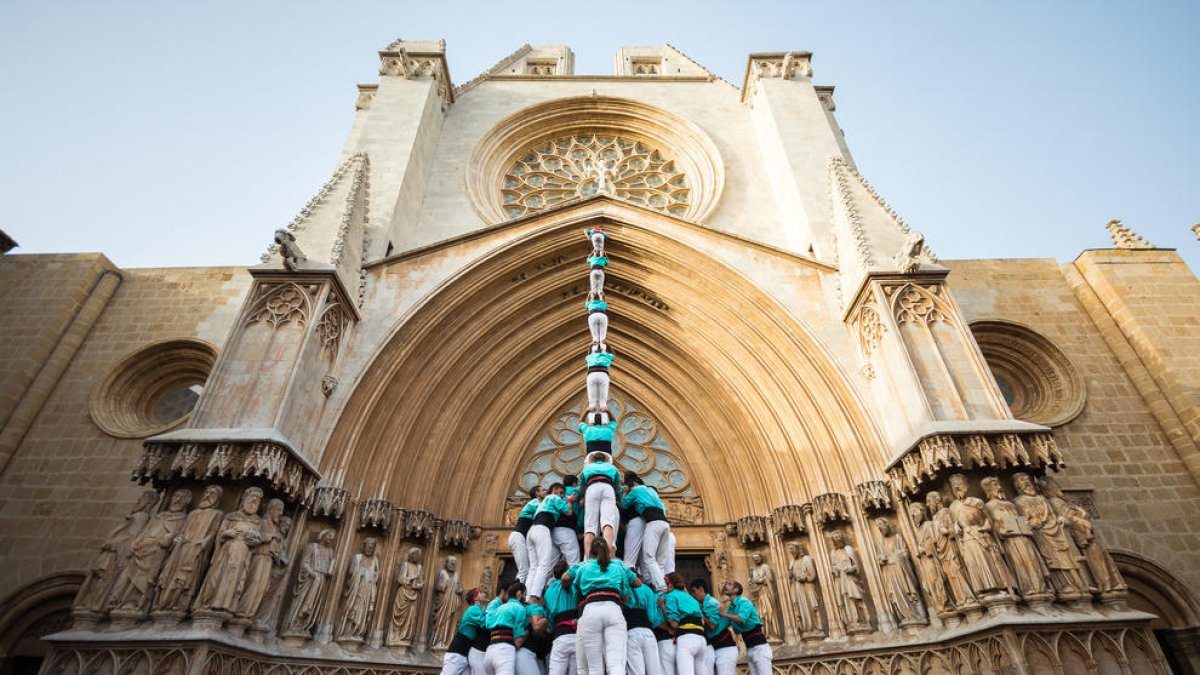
left=950, top=473, right=1013, bottom=598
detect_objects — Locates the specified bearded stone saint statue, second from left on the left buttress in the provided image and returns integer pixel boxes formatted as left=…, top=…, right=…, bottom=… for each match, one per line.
left=109, top=489, right=192, bottom=615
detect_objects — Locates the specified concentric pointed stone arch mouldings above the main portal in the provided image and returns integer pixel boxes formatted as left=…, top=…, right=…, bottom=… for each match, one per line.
left=322, top=209, right=880, bottom=522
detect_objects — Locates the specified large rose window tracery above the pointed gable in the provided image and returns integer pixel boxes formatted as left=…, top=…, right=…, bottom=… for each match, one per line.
left=500, top=133, right=690, bottom=219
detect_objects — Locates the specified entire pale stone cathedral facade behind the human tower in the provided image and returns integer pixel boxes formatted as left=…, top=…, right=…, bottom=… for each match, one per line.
left=0, top=41, right=1200, bottom=674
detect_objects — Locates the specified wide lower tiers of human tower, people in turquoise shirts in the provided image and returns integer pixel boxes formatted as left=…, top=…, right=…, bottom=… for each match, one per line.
left=443, top=444, right=772, bottom=675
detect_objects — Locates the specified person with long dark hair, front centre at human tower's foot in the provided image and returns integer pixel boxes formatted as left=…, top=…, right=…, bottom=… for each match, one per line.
left=563, top=539, right=642, bottom=675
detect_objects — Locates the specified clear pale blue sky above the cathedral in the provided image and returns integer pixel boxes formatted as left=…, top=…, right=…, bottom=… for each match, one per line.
left=0, top=0, right=1200, bottom=270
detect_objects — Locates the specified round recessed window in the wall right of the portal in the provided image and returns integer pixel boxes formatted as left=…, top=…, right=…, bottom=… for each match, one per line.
left=971, top=321, right=1085, bottom=426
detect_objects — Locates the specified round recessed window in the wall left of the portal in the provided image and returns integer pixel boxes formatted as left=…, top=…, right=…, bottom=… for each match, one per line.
left=91, top=340, right=216, bottom=438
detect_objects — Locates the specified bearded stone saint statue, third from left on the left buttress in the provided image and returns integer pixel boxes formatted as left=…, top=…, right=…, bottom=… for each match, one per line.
left=154, top=485, right=224, bottom=614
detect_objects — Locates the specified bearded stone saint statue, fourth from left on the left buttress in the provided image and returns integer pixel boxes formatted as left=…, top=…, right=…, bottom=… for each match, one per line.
left=193, top=488, right=263, bottom=614
